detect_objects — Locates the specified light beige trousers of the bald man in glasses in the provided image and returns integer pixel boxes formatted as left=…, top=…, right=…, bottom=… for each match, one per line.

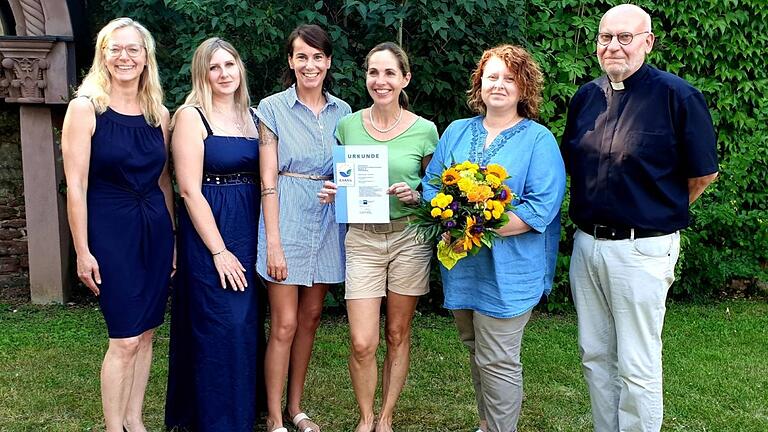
left=570, top=230, right=680, bottom=432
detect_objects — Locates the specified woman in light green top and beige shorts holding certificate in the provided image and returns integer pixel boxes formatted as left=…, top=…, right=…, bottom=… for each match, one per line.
left=319, top=42, right=438, bottom=432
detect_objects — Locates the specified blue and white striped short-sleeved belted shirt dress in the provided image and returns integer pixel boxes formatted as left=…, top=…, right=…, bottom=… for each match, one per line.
left=256, top=85, right=352, bottom=286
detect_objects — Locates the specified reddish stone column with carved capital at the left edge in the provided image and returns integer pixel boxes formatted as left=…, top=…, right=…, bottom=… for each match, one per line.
left=0, top=36, right=74, bottom=304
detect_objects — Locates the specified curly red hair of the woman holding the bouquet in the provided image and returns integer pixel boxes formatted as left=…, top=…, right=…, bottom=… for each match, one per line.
left=467, top=44, right=544, bottom=119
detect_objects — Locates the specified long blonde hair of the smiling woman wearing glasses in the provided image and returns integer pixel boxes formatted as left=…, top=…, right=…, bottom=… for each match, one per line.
left=76, top=17, right=163, bottom=126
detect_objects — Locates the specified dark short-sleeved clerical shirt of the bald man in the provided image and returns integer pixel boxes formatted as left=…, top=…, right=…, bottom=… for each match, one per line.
left=561, top=65, right=717, bottom=232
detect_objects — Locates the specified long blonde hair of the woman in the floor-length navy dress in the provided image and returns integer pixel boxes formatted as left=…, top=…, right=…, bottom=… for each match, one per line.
left=172, top=37, right=251, bottom=124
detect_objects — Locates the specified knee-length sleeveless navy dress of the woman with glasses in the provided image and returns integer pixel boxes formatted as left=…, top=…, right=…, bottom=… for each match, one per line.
left=87, top=108, right=173, bottom=338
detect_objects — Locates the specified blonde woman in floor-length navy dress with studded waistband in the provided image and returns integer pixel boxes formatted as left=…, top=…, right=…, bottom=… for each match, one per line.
left=166, top=38, right=265, bottom=432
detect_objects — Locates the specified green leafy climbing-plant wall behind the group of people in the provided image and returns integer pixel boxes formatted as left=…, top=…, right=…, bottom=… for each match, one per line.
left=90, top=0, right=768, bottom=310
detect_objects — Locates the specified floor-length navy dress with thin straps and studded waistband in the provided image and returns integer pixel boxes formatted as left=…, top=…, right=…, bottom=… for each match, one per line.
left=165, top=110, right=265, bottom=432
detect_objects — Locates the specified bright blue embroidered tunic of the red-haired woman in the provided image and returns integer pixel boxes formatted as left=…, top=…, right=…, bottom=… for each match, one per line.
left=422, top=116, right=565, bottom=318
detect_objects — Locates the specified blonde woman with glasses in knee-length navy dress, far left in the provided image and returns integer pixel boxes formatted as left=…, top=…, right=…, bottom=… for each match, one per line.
left=62, top=18, right=174, bottom=432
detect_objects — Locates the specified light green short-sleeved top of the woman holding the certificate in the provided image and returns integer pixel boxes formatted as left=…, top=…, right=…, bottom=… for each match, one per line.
left=336, top=110, right=438, bottom=219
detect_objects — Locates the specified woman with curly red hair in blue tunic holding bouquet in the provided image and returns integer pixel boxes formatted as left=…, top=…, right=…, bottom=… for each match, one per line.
left=422, top=45, right=565, bottom=432
